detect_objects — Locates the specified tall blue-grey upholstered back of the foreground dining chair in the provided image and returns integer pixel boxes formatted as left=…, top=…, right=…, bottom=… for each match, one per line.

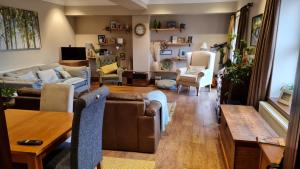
left=70, top=86, right=109, bottom=169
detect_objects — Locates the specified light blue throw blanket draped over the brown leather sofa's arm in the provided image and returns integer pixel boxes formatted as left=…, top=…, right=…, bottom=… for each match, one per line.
left=146, top=90, right=170, bottom=131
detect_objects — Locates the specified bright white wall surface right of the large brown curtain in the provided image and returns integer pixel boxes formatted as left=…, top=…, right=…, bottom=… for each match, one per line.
left=270, top=0, right=300, bottom=97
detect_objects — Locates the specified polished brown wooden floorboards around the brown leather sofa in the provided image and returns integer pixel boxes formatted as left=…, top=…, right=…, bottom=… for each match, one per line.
left=97, top=86, right=225, bottom=169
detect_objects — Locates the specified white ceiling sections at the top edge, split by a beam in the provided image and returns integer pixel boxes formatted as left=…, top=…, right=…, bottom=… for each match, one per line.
left=43, top=0, right=237, bottom=6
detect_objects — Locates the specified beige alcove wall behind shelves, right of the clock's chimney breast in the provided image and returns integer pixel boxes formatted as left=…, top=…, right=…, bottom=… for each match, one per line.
left=151, top=14, right=230, bottom=72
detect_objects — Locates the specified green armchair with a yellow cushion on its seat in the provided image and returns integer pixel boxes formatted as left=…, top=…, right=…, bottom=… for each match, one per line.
left=96, top=55, right=124, bottom=85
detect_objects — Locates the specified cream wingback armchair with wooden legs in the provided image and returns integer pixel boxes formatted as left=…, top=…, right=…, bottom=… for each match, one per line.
left=176, top=51, right=216, bottom=96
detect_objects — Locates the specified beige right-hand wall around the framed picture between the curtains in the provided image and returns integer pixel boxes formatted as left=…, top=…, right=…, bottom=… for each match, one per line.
left=237, top=0, right=266, bottom=43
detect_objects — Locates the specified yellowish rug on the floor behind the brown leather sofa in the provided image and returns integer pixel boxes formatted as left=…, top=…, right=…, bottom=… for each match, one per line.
left=101, top=157, right=155, bottom=169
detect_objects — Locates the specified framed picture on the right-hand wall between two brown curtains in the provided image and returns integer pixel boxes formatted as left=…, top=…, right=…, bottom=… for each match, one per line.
left=250, top=14, right=263, bottom=46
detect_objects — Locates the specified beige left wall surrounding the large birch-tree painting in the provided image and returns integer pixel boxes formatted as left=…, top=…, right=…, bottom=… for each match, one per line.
left=0, top=0, right=75, bottom=71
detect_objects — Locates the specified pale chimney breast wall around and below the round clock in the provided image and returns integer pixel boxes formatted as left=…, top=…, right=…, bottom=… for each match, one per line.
left=132, top=15, right=151, bottom=71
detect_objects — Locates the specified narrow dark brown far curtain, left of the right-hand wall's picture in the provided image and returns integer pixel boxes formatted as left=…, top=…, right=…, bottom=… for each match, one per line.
left=235, top=5, right=250, bottom=52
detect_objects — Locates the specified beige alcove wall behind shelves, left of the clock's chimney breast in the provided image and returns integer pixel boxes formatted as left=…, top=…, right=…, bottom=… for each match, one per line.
left=75, top=16, right=132, bottom=68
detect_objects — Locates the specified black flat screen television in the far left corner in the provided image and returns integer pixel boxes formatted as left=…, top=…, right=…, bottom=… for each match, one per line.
left=61, top=47, right=86, bottom=60
